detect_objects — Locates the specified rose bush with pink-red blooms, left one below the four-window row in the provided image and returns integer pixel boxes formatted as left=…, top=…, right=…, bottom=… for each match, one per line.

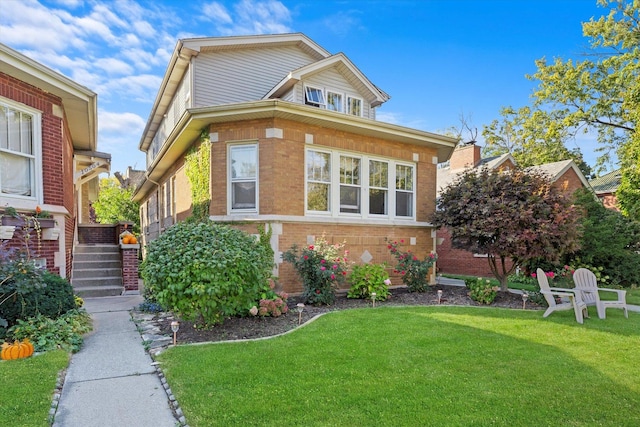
left=282, top=235, right=349, bottom=305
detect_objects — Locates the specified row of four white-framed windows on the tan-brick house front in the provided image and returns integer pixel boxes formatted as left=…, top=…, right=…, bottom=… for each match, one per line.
left=306, top=149, right=416, bottom=219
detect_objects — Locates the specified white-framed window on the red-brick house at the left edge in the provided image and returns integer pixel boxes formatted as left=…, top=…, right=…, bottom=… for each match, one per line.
left=0, top=99, right=42, bottom=202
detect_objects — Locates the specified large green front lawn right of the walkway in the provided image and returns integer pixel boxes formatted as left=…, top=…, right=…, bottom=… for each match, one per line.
left=160, top=307, right=640, bottom=426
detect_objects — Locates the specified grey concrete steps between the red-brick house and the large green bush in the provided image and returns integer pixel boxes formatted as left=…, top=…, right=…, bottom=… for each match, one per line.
left=71, top=244, right=124, bottom=298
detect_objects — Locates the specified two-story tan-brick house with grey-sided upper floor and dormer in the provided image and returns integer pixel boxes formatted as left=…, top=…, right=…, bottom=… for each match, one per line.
left=134, top=33, right=456, bottom=292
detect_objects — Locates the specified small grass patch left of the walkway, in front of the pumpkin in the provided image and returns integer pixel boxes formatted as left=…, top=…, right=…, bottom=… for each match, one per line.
left=0, top=350, right=69, bottom=427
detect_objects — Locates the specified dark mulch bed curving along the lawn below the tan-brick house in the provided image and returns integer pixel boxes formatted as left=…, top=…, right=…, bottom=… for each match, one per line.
left=154, top=285, right=540, bottom=344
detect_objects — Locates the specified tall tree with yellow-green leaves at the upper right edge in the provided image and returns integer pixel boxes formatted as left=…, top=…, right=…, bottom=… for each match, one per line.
left=528, top=0, right=640, bottom=215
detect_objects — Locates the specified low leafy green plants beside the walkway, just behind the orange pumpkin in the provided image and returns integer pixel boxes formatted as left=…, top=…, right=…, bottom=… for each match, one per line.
left=9, top=309, right=91, bottom=353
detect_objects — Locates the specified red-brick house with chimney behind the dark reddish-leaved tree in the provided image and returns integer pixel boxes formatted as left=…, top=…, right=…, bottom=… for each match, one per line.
left=437, top=144, right=590, bottom=277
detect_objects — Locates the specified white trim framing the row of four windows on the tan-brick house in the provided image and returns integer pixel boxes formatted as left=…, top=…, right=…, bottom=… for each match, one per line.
left=304, top=147, right=418, bottom=222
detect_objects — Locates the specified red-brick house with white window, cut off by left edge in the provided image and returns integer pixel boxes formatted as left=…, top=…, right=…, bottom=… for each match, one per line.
left=0, top=44, right=110, bottom=277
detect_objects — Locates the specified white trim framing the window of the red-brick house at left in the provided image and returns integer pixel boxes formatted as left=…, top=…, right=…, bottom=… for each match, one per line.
left=0, top=97, right=44, bottom=209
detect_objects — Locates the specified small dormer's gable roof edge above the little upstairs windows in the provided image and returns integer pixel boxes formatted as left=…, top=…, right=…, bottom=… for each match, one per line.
left=264, top=52, right=390, bottom=107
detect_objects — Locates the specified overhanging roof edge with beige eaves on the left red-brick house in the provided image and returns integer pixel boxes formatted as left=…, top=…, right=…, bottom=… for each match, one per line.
left=0, top=43, right=98, bottom=150
